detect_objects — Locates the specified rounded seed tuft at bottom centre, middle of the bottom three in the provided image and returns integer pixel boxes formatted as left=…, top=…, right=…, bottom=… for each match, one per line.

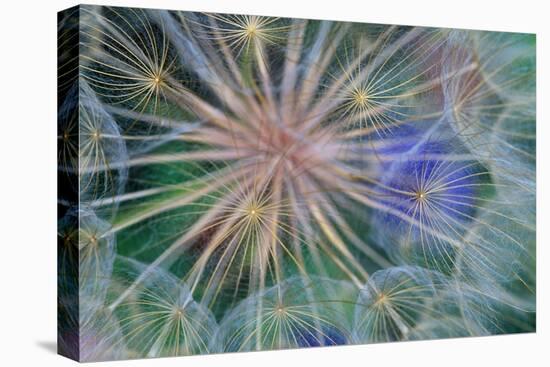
left=213, top=278, right=349, bottom=351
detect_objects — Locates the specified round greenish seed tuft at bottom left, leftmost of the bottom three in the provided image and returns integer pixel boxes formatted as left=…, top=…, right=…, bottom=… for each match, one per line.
left=108, top=259, right=216, bottom=357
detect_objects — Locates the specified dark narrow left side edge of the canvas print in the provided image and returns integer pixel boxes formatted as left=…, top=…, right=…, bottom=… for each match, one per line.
left=57, top=6, right=80, bottom=360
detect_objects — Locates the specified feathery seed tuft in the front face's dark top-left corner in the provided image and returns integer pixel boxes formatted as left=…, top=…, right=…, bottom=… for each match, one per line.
left=80, top=8, right=181, bottom=129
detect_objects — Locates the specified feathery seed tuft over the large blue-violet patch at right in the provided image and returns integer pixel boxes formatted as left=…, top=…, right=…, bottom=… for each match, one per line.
left=375, top=138, right=491, bottom=272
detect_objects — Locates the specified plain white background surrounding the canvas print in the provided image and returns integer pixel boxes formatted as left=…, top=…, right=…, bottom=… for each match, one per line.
left=0, top=0, right=550, bottom=367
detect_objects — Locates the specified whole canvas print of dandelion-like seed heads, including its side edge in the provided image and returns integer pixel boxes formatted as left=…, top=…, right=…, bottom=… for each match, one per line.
left=57, top=5, right=536, bottom=361
